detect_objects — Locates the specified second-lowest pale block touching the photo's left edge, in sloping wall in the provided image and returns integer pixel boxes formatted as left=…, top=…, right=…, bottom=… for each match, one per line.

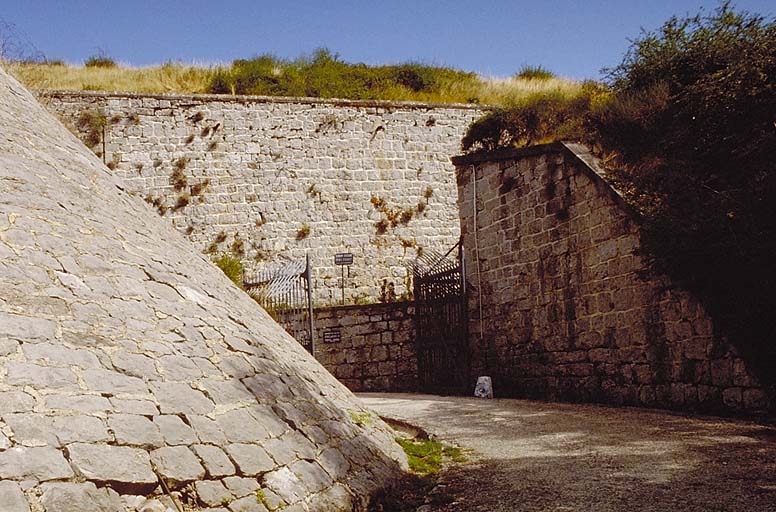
left=0, top=446, right=73, bottom=482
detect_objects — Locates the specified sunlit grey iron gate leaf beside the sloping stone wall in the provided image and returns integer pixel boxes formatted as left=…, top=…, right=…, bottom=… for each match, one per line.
left=243, top=256, right=315, bottom=355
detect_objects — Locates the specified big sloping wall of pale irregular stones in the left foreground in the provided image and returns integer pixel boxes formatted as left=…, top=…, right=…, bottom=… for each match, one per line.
left=0, top=66, right=402, bottom=512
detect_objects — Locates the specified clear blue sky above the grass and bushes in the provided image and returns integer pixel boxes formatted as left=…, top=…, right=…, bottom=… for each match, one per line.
left=0, top=0, right=776, bottom=79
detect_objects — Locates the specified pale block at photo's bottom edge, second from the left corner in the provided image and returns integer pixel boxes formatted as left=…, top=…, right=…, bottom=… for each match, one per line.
left=40, top=482, right=123, bottom=512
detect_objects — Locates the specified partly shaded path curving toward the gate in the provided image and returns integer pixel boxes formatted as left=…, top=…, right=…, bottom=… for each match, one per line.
left=359, top=394, right=776, bottom=512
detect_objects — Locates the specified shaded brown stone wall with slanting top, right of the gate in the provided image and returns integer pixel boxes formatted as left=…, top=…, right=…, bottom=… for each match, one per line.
left=453, top=144, right=768, bottom=413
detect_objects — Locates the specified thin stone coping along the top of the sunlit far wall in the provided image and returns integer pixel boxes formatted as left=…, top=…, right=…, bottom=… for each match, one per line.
left=35, top=90, right=493, bottom=110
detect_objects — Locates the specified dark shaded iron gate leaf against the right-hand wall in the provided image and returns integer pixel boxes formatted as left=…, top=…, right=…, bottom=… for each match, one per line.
left=412, top=242, right=470, bottom=394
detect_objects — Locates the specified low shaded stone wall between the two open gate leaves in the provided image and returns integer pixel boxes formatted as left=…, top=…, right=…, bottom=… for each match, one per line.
left=315, top=302, right=418, bottom=392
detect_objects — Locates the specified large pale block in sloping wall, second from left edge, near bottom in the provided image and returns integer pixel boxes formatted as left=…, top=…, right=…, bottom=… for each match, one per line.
left=67, top=443, right=157, bottom=492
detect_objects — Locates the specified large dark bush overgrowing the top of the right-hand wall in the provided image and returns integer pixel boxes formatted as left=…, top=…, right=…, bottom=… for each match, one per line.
left=463, top=4, right=776, bottom=394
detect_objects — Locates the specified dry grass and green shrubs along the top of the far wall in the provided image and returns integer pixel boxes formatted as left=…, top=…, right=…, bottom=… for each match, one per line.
left=4, top=50, right=582, bottom=105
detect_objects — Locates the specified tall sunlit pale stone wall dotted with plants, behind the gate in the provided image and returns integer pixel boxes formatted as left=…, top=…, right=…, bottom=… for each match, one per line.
left=41, top=92, right=481, bottom=303
